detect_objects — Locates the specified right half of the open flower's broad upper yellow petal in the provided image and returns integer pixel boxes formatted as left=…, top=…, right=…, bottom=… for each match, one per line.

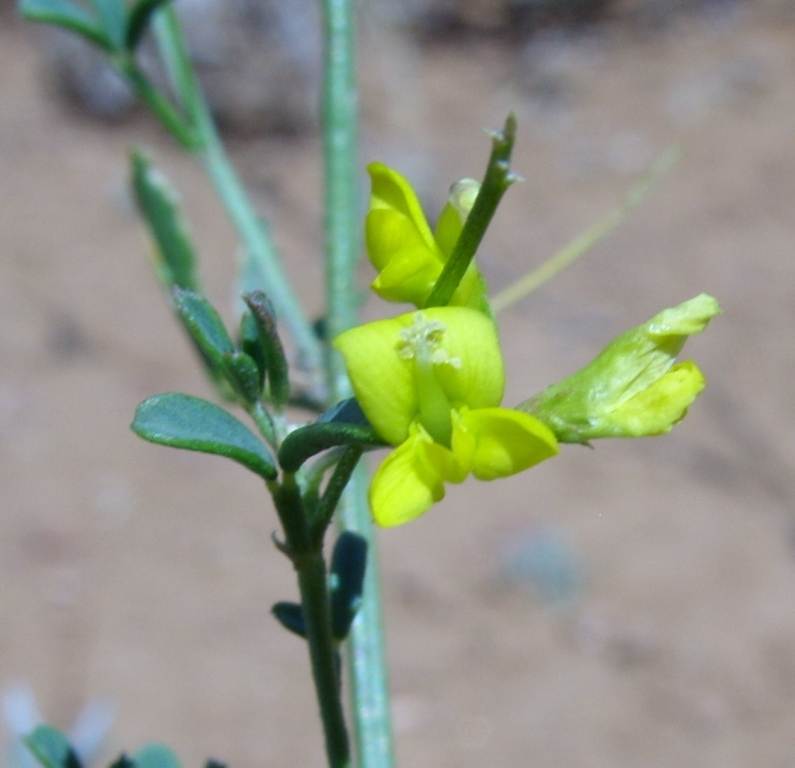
left=424, top=307, right=505, bottom=408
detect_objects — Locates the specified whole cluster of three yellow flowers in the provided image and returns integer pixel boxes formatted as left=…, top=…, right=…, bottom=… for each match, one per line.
left=334, top=163, right=720, bottom=526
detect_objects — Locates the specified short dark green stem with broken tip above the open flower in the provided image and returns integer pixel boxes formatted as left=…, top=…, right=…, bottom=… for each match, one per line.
left=425, top=112, right=517, bottom=307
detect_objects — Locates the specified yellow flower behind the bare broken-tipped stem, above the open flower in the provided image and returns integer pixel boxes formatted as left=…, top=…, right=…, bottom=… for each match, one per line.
left=365, top=163, right=489, bottom=313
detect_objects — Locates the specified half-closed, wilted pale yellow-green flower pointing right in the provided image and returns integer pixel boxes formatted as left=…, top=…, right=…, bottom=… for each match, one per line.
left=518, top=293, right=721, bottom=443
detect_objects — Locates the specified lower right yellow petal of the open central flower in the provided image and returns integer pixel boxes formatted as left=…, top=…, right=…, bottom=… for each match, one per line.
left=453, top=408, right=558, bottom=480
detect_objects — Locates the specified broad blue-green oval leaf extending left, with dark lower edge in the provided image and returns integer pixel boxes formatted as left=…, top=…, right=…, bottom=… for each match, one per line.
left=131, top=392, right=276, bottom=480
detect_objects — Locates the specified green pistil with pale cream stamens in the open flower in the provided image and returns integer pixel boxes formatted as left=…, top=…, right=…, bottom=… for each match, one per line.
left=397, top=312, right=461, bottom=448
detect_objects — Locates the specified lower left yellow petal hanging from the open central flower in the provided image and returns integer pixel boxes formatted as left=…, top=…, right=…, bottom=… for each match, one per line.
left=370, top=430, right=444, bottom=527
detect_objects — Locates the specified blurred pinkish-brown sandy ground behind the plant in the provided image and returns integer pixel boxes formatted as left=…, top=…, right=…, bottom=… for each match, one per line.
left=0, top=6, right=795, bottom=768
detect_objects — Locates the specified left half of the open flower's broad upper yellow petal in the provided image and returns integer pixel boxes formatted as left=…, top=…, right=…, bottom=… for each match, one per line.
left=334, top=314, right=418, bottom=445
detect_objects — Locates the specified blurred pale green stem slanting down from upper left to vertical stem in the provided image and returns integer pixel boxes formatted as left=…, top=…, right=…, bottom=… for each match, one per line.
left=148, top=6, right=323, bottom=396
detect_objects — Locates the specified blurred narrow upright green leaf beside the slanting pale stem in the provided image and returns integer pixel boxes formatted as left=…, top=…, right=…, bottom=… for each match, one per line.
left=130, top=150, right=200, bottom=291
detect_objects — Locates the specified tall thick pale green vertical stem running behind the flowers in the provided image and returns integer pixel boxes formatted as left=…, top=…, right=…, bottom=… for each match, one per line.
left=322, top=0, right=394, bottom=768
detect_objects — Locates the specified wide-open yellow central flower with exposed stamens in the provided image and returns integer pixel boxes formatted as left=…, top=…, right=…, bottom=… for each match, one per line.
left=334, top=307, right=557, bottom=526
